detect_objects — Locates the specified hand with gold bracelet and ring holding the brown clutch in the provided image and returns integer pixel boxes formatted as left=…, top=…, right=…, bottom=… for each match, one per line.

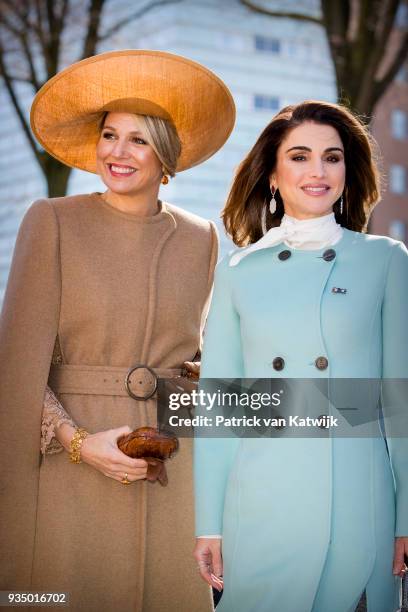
left=56, top=423, right=148, bottom=482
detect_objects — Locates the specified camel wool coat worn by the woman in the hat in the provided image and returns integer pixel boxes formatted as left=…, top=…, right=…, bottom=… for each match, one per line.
left=0, top=193, right=218, bottom=612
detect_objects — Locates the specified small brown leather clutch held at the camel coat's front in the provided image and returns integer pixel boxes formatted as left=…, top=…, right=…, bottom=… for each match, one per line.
left=118, top=427, right=178, bottom=461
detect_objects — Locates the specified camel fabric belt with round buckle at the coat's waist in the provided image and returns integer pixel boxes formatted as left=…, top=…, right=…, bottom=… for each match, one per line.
left=48, top=364, right=183, bottom=400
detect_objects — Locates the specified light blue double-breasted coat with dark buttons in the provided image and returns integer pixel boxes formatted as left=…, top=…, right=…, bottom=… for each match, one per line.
left=195, top=230, right=408, bottom=612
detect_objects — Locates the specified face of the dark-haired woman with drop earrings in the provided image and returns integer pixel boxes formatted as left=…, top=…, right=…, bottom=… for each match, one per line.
left=270, top=121, right=346, bottom=219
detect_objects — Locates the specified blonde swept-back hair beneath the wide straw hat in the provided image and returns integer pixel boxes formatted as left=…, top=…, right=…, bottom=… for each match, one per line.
left=99, top=112, right=181, bottom=177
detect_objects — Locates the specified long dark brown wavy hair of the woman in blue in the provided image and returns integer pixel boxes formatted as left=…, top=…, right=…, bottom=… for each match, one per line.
left=221, top=100, right=380, bottom=246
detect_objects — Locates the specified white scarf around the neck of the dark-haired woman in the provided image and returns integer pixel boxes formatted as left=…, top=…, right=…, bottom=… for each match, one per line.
left=229, top=212, right=343, bottom=266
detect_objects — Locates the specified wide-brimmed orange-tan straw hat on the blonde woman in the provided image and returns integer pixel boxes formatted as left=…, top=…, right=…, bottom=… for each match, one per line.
left=31, top=49, right=235, bottom=172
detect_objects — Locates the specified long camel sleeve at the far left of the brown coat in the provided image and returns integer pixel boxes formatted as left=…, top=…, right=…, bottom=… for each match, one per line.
left=0, top=201, right=61, bottom=589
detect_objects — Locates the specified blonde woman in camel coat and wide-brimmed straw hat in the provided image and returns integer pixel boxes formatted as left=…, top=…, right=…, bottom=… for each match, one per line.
left=0, top=51, right=234, bottom=612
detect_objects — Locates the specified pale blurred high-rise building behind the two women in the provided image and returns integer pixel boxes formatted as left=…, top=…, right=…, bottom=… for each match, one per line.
left=0, top=0, right=336, bottom=301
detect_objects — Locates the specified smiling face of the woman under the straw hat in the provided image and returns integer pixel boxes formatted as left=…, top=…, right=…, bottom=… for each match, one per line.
left=96, top=113, right=163, bottom=196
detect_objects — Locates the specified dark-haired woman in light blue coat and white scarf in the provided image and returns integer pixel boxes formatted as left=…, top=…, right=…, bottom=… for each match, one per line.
left=195, top=101, right=408, bottom=612
